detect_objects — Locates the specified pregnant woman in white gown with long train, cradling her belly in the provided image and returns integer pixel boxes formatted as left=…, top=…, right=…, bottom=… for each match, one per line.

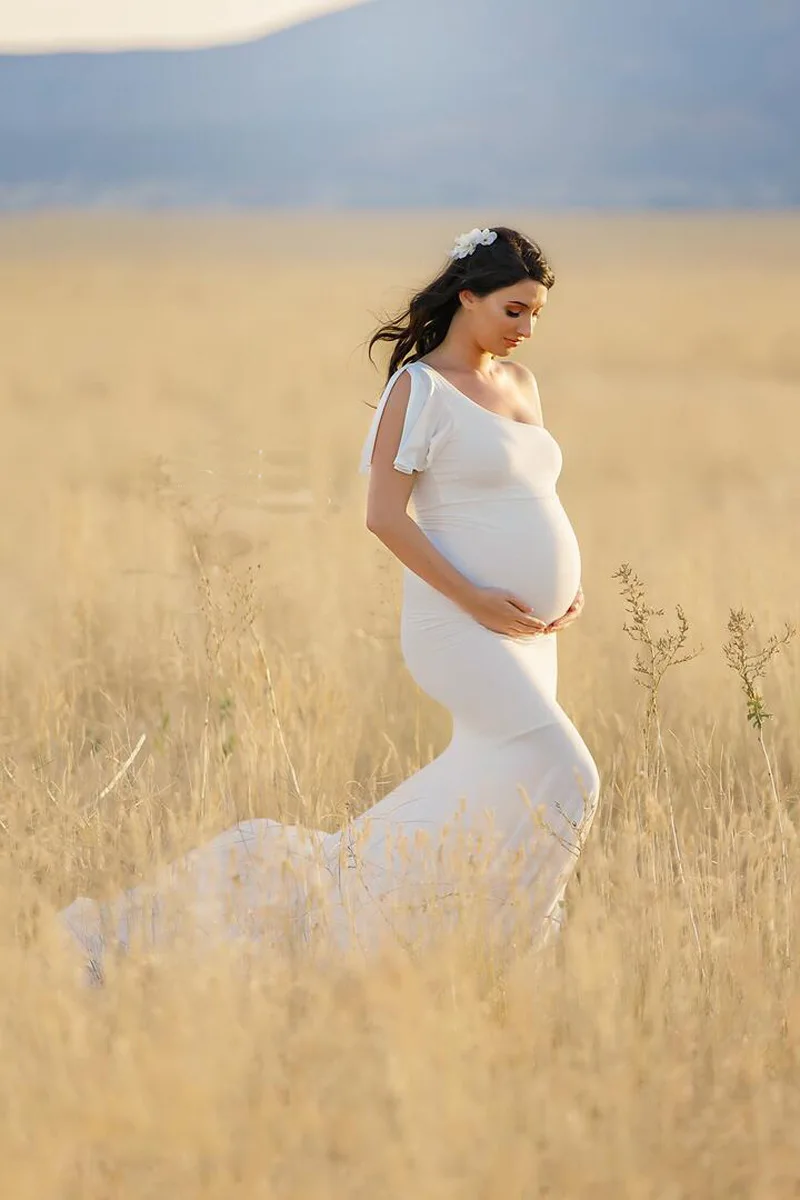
left=60, top=227, right=600, bottom=974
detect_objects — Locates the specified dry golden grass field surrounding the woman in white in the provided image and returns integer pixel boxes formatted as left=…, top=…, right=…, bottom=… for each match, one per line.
left=0, top=212, right=800, bottom=1200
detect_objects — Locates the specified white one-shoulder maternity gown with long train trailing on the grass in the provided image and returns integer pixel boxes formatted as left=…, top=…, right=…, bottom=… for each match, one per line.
left=60, top=362, right=600, bottom=971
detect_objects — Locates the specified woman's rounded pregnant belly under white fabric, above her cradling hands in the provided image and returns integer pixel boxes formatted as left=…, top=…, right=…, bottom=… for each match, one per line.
left=404, top=494, right=581, bottom=623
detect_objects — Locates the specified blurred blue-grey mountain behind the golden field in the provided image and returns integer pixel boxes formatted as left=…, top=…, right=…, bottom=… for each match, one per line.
left=0, top=0, right=800, bottom=208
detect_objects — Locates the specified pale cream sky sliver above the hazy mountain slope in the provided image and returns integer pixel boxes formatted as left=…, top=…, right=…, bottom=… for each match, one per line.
left=0, top=0, right=362, bottom=52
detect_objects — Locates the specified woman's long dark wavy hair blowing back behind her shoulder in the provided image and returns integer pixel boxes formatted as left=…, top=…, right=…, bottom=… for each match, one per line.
left=369, top=226, right=555, bottom=382
